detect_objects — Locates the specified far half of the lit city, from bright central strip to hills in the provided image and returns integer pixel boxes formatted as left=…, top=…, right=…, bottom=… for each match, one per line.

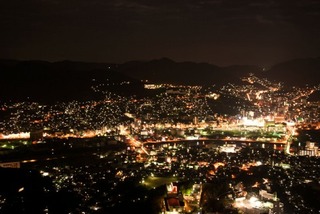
left=0, top=75, right=320, bottom=141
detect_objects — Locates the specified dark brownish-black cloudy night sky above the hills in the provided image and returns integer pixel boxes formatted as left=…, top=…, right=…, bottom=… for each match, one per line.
left=0, top=0, right=320, bottom=66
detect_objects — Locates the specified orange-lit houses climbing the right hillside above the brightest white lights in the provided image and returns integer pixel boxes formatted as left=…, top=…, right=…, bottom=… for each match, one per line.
left=217, top=74, right=320, bottom=126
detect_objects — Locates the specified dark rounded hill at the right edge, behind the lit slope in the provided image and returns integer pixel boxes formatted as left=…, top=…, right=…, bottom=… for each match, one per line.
left=262, top=57, right=320, bottom=86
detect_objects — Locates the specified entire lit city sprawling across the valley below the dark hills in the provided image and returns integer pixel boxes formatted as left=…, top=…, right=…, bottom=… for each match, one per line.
left=0, top=75, right=320, bottom=213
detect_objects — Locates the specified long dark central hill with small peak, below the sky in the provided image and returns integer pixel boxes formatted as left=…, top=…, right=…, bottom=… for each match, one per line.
left=118, top=58, right=260, bottom=85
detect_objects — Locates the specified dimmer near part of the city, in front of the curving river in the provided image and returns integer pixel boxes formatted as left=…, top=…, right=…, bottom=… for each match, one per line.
left=1, top=137, right=320, bottom=213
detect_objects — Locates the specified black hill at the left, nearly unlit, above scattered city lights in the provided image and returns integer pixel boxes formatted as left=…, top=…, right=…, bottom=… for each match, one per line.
left=0, top=60, right=142, bottom=103
